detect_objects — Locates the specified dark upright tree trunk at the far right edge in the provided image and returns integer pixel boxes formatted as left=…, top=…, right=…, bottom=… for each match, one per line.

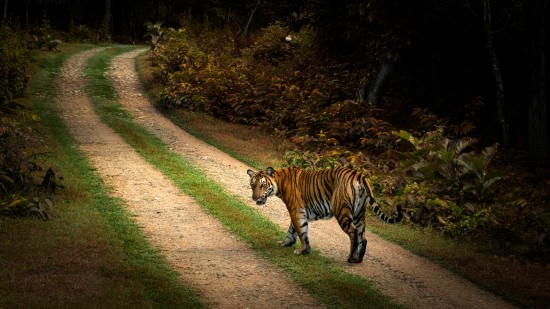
left=528, top=0, right=550, bottom=161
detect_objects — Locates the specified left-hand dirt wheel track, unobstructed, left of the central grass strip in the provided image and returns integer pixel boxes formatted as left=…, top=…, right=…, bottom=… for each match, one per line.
left=57, top=48, right=323, bottom=308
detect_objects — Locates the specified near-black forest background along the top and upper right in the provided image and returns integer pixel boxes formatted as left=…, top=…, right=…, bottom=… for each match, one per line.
left=2, top=0, right=550, bottom=161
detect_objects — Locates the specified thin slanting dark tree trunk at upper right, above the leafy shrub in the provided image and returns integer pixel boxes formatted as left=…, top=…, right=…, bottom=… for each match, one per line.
left=483, top=0, right=510, bottom=146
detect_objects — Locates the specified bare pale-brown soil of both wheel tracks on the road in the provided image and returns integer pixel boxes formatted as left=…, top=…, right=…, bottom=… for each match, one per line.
left=58, top=48, right=513, bottom=308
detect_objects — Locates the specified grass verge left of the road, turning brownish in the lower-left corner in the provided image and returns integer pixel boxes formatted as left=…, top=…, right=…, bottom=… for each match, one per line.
left=0, top=45, right=202, bottom=308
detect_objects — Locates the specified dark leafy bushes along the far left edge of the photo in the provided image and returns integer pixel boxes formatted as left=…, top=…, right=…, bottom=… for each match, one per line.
left=0, top=25, right=55, bottom=218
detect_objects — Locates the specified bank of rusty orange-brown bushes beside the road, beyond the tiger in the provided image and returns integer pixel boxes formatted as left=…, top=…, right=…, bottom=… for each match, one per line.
left=151, top=24, right=391, bottom=150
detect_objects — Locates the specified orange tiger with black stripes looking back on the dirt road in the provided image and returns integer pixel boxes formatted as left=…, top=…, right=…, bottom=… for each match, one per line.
left=247, top=167, right=403, bottom=263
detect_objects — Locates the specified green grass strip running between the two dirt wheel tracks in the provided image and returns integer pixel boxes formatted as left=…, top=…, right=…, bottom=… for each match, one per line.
left=86, top=48, right=404, bottom=308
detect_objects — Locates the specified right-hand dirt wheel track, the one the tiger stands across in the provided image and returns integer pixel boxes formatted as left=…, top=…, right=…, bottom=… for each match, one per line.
left=109, top=50, right=514, bottom=308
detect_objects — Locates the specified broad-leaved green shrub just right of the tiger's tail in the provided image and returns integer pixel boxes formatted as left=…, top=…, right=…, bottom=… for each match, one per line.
left=393, top=128, right=503, bottom=236
